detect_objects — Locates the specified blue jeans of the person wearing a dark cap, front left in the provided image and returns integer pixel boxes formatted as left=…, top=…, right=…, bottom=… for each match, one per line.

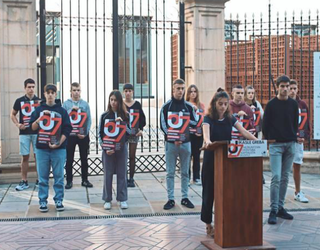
left=36, top=149, right=66, bottom=203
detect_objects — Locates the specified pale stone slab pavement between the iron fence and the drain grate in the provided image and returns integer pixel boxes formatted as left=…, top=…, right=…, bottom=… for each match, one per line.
left=0, top=172, right=320, bottom=218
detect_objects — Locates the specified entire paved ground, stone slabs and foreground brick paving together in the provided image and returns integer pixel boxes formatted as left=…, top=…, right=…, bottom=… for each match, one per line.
left=0, top=172, right=320, bottom=250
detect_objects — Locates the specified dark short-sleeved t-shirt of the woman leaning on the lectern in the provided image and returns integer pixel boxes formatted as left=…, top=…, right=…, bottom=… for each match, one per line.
left=202, top=115, right=237, bottom=142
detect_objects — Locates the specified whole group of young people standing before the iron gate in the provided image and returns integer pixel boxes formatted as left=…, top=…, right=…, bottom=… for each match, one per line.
left=11, top=76, right=310, bottom=235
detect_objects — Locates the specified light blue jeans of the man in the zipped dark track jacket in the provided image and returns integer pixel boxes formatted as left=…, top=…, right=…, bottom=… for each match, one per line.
left=166, top=142, right=191, bottom=200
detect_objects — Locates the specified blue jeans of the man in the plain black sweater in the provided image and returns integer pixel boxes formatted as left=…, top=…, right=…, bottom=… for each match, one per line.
left=269, top=142, right=295, bottom=211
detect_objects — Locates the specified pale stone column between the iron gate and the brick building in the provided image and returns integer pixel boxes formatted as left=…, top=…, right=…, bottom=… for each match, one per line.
left=185, top=0, right=229, bottom=107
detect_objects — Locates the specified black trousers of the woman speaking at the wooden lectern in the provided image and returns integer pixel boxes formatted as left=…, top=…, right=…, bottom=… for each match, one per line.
left=201, top=151, right=214, bottom=224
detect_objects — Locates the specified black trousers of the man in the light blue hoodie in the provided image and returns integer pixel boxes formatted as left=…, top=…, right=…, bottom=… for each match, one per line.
left=66, top=135, right=90, bottom=182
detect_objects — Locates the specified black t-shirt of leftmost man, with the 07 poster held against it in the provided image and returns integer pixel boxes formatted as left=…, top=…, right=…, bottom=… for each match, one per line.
left=13, top=95, right=41, bottom=135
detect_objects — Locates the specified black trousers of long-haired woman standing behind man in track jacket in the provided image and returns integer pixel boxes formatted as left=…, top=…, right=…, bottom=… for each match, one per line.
left=189, top=134, right=203, bottom=181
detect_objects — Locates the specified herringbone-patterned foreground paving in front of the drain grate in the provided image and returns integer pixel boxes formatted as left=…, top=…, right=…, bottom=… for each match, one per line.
left=0, top=212, right=320, bottom=250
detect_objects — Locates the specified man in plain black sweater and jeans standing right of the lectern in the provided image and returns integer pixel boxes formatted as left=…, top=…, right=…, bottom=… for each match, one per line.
left=262, top=75, right=303, bottom=224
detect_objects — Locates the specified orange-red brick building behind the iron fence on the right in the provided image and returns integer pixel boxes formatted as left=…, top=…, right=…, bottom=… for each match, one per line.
left=225, top=35, right=320, bottom=148
